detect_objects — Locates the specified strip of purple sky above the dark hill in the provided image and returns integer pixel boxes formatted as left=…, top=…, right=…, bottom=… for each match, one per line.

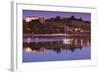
left=23, top=10, right=91, bottom=21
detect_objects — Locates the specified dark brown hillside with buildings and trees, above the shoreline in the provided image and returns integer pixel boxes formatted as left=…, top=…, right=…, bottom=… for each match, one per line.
left=23, top=16, right=91, bottom=35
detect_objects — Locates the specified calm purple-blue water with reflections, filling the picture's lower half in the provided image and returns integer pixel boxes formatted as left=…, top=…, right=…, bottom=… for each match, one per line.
left=23, top=37, right=91, bottom=62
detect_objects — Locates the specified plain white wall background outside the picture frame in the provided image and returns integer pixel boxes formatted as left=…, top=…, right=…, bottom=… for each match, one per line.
left=0, top=0, right=100, bottom=73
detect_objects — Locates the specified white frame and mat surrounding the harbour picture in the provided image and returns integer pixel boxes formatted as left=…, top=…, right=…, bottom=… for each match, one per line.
left=11, top=2, right=97, bottom=71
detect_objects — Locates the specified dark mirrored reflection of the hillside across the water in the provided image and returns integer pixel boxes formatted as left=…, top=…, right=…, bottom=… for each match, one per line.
left=23, top=37, right=90, bottom=53
